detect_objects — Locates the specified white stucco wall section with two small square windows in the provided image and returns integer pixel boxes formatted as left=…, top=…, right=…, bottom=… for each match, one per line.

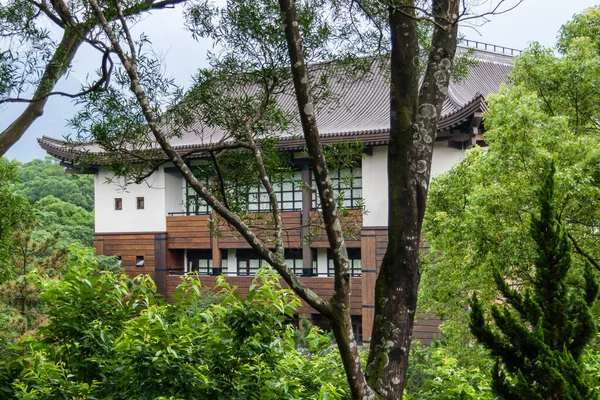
left=94, top=169, right=167, bottom=233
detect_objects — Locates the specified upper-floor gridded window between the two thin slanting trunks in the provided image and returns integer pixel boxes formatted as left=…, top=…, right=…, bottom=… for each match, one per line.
left=248, top=171, right=303, bottom=212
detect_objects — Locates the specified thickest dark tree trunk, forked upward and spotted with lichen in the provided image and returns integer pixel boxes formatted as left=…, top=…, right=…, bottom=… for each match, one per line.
left=367, top=0, right=459, bottom=399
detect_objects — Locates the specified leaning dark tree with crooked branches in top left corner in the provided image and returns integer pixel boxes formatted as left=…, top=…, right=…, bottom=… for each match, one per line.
left=0, top=0, right=191, bottom=156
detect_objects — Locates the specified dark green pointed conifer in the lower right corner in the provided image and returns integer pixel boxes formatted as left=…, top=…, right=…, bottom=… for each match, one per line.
left=469, top=166, right=598, bottom=400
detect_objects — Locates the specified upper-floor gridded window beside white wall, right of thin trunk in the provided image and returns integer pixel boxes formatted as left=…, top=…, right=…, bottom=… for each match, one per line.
left=313, top=168, right=363, bottom=209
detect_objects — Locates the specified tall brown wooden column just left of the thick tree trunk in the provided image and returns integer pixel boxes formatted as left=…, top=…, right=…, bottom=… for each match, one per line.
left=360, top=229, right=377, bottom=345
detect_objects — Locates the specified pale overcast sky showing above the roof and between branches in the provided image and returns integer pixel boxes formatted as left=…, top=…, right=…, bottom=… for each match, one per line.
left=0, top=0, right=600, bottom=162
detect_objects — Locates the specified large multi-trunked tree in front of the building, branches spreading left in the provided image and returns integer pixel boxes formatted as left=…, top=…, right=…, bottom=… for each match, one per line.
left=68, top=0, right=520, bottom=399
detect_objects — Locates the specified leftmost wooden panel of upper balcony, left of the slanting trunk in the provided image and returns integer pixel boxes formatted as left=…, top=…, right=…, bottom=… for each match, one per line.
left=167, top=215, right=212, bottom=249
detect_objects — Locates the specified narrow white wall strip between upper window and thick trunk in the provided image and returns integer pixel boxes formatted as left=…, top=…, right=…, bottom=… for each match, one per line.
left=362, top=146, right=388, bottom=227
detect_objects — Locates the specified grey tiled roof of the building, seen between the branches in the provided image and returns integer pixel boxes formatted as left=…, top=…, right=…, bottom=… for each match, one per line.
left=38, top=48, right=512, bottom=160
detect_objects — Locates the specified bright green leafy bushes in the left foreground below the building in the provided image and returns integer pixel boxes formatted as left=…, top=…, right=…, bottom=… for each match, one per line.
left=0, top=258, right=348, bottom=399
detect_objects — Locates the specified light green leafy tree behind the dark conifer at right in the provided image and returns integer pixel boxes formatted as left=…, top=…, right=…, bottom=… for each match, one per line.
left=420, top=9, right=600, bottom=345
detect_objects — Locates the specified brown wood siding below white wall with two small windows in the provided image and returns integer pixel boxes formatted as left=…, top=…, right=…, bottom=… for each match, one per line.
left=94, top=233, right=156, bottom=279
